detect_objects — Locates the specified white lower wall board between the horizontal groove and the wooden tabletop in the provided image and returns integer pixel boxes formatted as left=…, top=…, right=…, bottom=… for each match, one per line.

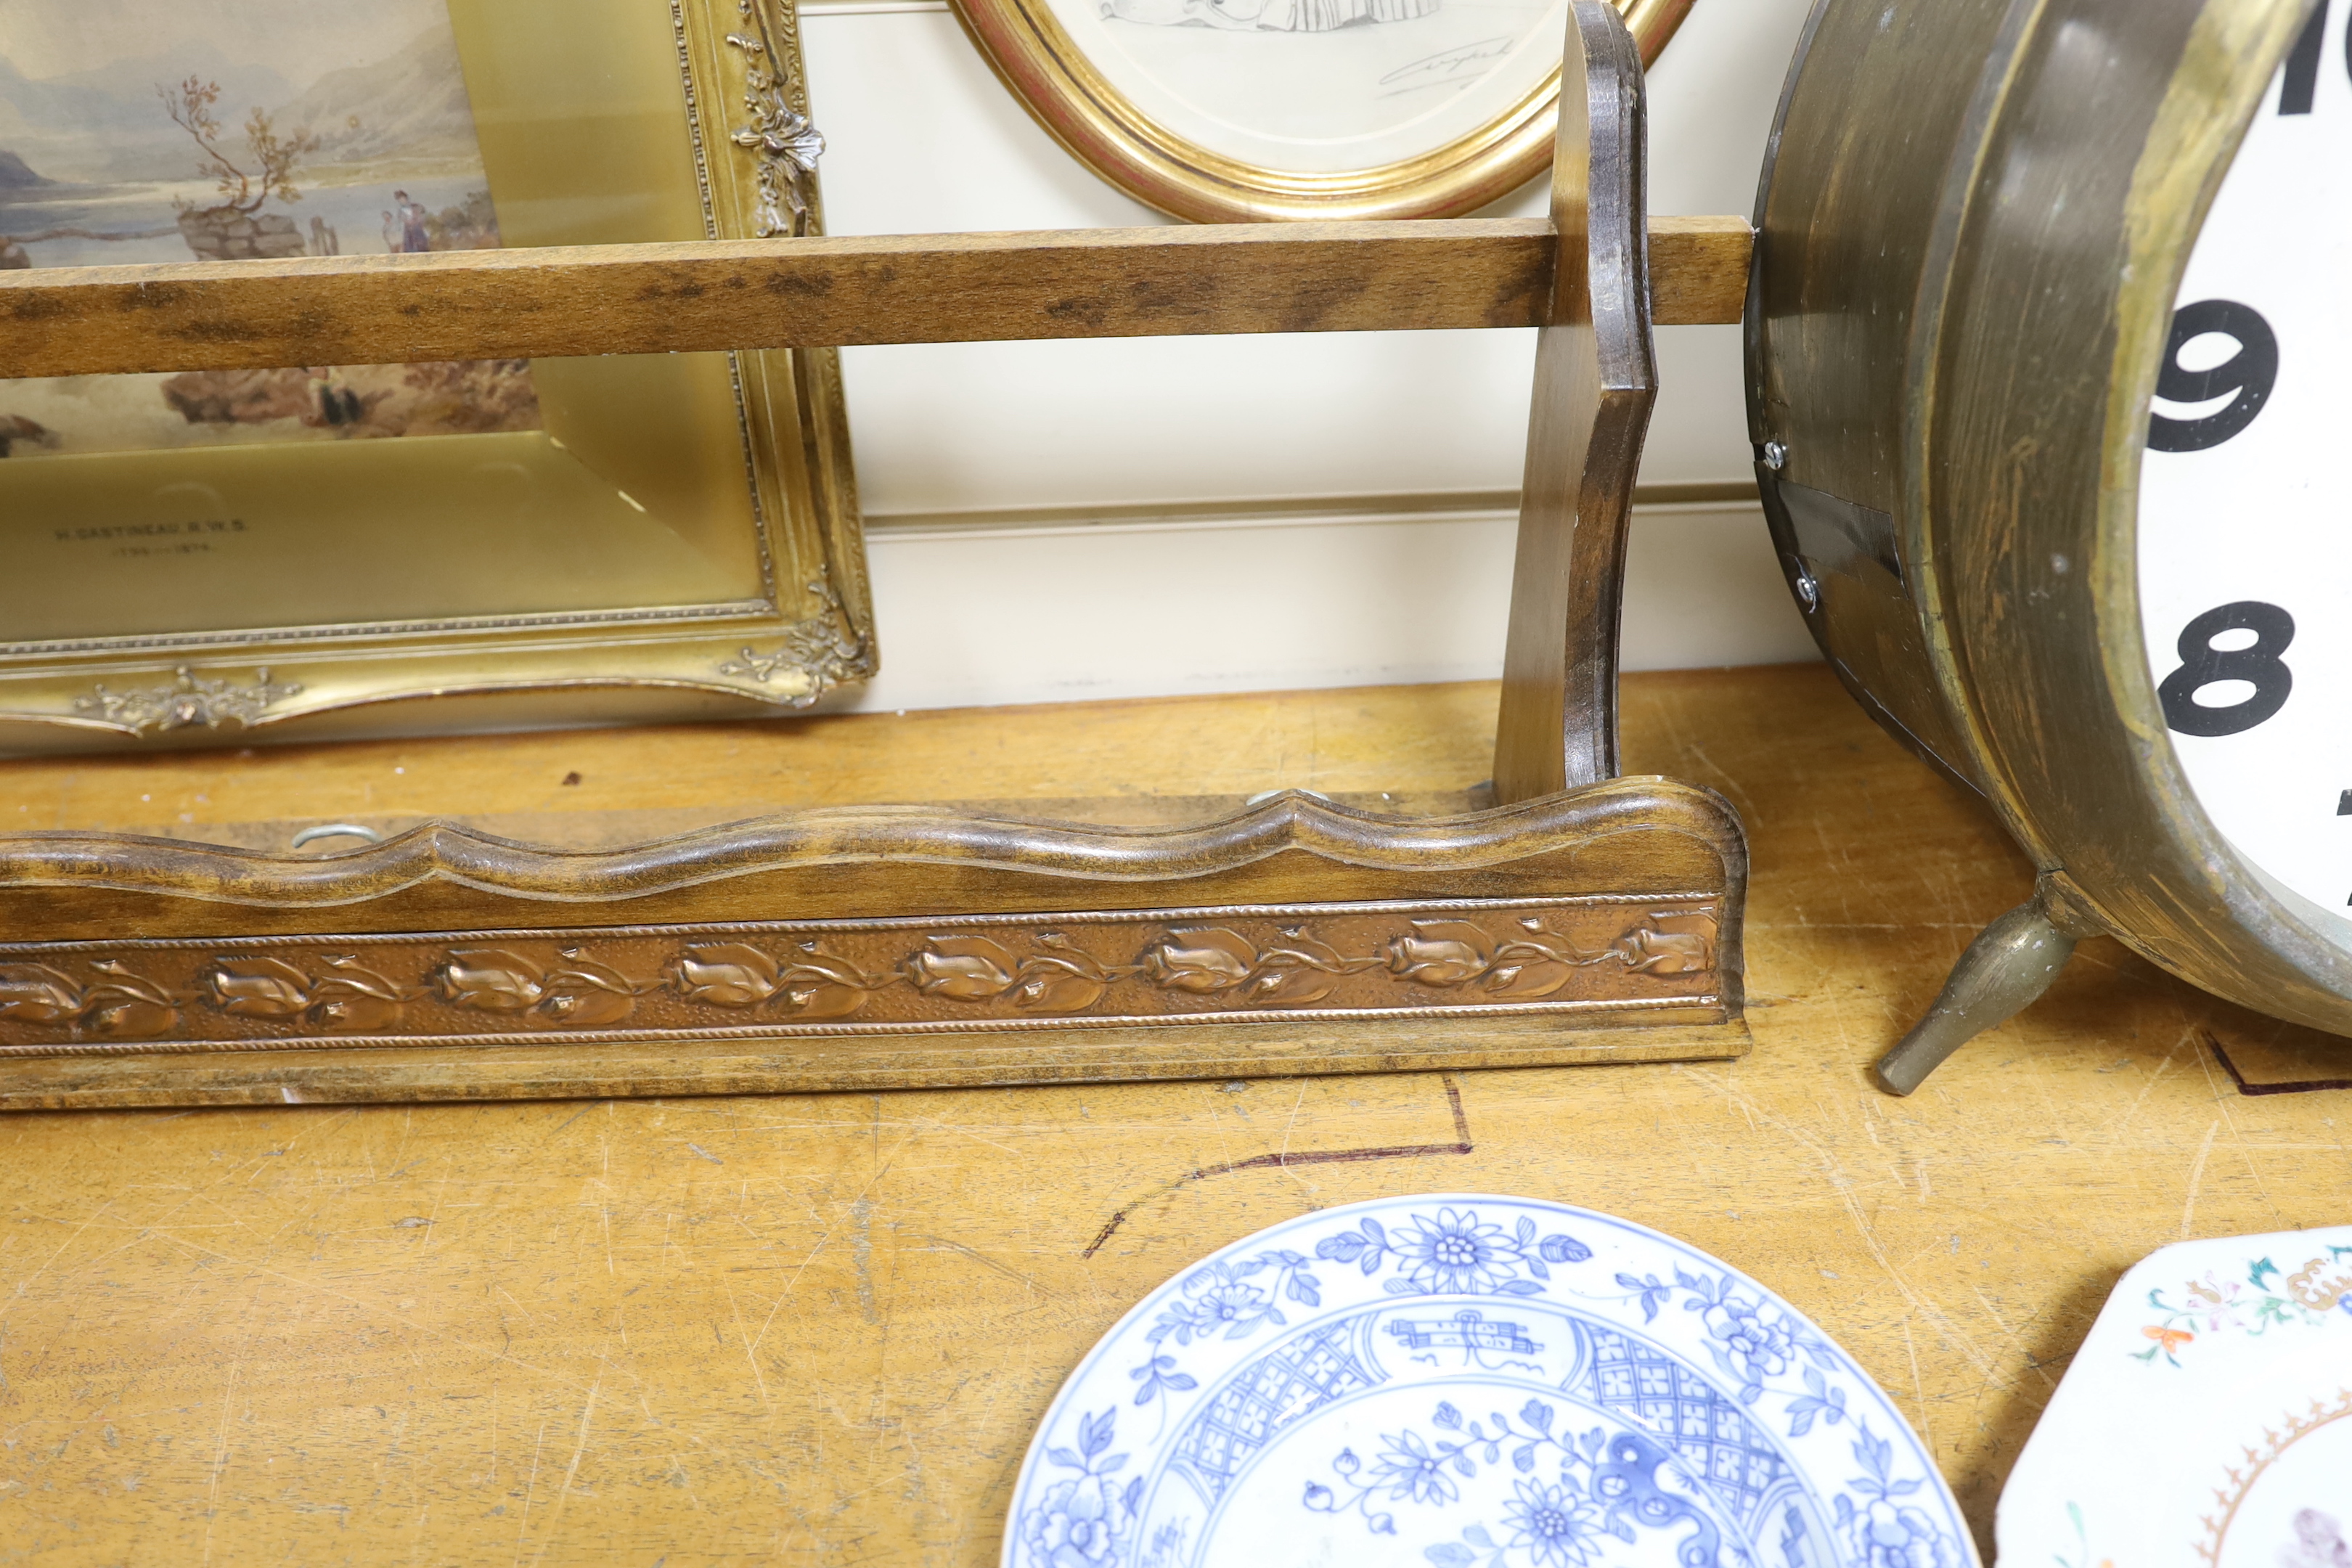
left=825, top=503, right=1818, bottom=712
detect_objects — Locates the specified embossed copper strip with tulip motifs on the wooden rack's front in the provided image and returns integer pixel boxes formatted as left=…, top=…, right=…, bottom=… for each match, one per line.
left=0, top=896, right=1722, bottom=1055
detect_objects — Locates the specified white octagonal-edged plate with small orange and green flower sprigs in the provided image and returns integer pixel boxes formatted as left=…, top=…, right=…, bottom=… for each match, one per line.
left=1995, top=1225, right=2352, bottom=1568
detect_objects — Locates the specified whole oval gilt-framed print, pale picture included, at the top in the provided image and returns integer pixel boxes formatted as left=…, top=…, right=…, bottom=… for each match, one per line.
left=955, top=0, right=1691, bottom=224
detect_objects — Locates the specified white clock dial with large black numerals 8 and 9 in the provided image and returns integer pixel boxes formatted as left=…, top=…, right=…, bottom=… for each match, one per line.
left=2140, top=0, right=2352, bottom=936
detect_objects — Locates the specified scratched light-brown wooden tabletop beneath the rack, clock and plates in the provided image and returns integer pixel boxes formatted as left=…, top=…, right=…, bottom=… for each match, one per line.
left=0, top=668, right=2352, bottom=1568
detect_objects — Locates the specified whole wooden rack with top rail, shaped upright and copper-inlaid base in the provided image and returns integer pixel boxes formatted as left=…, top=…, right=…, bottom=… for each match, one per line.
left=0, top=0, right=1750, bottom=1107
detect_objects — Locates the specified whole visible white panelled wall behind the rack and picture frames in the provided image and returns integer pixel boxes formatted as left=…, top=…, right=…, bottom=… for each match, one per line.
left=802, top=0, right=1813, bottom=708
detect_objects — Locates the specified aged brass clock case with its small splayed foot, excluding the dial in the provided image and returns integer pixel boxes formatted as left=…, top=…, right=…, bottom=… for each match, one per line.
left=1747, top=0, right=2352, bottom=1053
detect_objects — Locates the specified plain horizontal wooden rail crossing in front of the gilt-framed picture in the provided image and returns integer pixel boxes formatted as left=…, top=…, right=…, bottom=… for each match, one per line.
left=0, top=219, right=1750, bottom=376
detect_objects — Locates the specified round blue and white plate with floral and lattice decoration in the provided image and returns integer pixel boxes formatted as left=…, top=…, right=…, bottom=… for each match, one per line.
left=1004, top=1194, right=1973, bottom=1568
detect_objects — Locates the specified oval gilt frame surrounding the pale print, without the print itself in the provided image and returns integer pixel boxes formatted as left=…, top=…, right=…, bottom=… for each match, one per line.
left=952, top=0, right=1694, bottom=224
